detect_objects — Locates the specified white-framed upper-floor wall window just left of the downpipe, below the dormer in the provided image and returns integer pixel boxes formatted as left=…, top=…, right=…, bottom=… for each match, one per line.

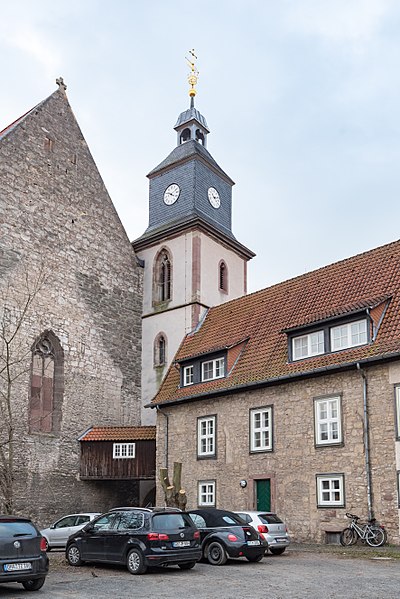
left=314, top=396, right=342, bottom=445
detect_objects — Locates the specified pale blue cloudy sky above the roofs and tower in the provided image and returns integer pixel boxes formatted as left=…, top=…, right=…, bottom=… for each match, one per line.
left=0, top=0, right=400, bottom=291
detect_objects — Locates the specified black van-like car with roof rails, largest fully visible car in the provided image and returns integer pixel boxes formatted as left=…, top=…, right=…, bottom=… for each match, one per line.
left=66, top=508, right=201, bottom=574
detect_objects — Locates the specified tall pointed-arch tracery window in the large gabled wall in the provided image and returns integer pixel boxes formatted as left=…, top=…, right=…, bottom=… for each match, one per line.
left=29, top=331, right=64, bottom=433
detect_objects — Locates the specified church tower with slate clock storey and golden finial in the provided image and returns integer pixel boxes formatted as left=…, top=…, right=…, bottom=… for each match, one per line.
left=132, top=52, right=254, bottom=424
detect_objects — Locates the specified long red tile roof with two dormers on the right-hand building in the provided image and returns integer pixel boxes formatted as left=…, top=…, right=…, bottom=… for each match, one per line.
left=152, top=241, right=400, bottom=405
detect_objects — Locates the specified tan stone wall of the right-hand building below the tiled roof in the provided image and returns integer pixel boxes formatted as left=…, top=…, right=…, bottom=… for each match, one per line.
left=157, top=365, right=400, bottom=543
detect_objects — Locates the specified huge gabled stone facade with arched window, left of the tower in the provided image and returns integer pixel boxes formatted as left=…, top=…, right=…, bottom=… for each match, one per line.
left=0, top=85, right=142, bottom=521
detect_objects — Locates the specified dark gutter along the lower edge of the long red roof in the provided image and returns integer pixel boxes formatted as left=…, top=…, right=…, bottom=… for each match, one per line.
left=145, top=351, right=400, bottom=409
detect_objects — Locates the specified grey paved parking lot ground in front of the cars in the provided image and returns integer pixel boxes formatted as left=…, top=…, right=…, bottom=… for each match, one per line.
left=0, top=547, right=400, bottom=599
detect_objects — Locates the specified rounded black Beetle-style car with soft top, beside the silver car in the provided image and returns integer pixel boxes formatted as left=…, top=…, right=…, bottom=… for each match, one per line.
left=187, top=508, right=268, bottom=566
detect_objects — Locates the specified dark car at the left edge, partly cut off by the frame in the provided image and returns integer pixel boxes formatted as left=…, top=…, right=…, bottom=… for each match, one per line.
left=0, top=515, right=49, bottom=591
